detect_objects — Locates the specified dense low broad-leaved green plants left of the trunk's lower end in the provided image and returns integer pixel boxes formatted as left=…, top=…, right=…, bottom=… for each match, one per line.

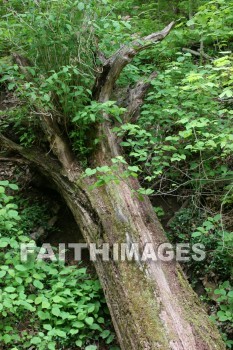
left=0, top=185, right=114, bottom=350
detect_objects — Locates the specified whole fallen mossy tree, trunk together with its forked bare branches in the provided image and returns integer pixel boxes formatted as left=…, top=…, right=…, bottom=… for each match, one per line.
left=0, top=23, right=225, bottom=350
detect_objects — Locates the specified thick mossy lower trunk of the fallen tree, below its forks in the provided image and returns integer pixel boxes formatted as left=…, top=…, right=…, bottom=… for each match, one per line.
left=47, top=168, right=225, bottom=350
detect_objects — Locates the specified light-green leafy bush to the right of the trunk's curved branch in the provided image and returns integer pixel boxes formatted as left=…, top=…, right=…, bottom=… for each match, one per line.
left=116, top=54, right=232, bottom=200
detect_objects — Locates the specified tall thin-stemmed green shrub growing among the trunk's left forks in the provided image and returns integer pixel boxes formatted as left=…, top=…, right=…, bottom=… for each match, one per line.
left=0, top=0, right=95, bottom=153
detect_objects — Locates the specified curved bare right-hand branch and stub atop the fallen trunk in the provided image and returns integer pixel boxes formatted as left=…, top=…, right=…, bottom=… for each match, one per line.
left=92, top=22, right=175, bottom=164
